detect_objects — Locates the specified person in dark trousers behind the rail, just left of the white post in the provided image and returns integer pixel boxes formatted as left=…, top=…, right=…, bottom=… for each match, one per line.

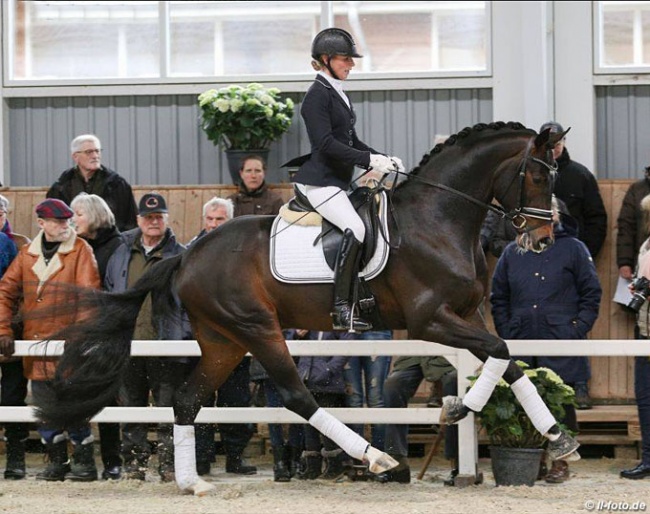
left=384, top=357, right=458, bottom=485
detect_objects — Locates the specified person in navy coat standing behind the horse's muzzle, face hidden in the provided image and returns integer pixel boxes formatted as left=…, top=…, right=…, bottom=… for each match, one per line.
left=490, top=200, right=602, bottom=483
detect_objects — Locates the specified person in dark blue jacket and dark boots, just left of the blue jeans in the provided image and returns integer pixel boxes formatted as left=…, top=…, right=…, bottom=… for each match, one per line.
left=298, top=331, right=349, bottom=480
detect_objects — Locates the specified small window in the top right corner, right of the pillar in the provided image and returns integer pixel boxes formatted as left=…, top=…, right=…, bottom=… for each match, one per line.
left=594, top=1, right=650, bottom=73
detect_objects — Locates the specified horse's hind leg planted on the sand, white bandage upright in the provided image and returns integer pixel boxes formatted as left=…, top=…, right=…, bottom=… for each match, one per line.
left=174, top=334, right=245, bottom=496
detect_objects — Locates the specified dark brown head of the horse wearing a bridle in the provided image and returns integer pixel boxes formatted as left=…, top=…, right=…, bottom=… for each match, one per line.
left=502, top=125, right=570, bottom=252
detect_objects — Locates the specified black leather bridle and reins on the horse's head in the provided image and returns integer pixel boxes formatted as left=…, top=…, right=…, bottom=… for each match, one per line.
left=382, top=139, right=557, bottom=230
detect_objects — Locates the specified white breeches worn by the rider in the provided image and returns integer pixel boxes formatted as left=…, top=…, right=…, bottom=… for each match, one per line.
left=297, top=184, right=366, bottom=243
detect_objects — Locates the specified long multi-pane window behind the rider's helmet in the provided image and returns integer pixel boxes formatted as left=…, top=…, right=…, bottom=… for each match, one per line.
left=2, top=0, right=490, bottom=86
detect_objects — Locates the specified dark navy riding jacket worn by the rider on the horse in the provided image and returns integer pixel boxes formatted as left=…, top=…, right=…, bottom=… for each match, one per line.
left=293, top=75, right=380, bottom=191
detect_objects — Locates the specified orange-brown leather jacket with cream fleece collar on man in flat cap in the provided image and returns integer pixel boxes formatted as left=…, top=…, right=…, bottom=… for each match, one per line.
left=0, top=231, right=100, bottom=380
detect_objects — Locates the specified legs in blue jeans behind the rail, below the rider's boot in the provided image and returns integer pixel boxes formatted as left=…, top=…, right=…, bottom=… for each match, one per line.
left=343, top=330, right=393, bottom=451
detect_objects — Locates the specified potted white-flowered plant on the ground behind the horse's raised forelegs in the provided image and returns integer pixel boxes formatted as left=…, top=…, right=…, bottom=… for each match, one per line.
left=469, top=361, right=575, bottom=486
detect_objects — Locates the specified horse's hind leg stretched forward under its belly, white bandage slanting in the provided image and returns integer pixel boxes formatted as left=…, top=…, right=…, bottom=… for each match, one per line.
left=251, top=329, right=398, bottom=473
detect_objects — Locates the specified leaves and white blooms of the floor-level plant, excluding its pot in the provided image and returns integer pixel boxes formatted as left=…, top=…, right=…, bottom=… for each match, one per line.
left=468, top=361, right=575, bottom=448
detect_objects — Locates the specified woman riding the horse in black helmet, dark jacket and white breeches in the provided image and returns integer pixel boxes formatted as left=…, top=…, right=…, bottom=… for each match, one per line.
left=293, top=28, right=404, bottom=331
